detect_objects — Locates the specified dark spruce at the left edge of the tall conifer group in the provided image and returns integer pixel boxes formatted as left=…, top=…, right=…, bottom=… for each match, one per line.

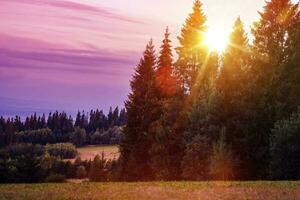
left=120, top=40, right=159, bottom=180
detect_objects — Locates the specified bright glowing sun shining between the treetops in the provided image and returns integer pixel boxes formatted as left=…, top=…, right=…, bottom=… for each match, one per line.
left=204, top=28, right=228, bottom=53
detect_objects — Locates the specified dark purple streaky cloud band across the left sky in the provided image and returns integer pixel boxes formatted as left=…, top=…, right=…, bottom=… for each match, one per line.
left=0, top=49, right=136, bottom=76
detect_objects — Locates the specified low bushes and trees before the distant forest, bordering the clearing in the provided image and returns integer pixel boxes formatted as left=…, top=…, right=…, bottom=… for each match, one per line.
left=0, top=143, right=116, bottom=183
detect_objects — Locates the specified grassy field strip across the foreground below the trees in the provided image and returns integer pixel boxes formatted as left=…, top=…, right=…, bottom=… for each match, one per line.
left=0, top=182, right=300, bottom=200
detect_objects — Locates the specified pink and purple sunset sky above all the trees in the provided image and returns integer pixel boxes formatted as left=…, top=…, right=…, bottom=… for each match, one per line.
left=0, top=0, right=284, bottom=116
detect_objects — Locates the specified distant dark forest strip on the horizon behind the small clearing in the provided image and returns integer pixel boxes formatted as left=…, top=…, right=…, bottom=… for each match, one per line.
left=0, top=107, right=126, bottom=147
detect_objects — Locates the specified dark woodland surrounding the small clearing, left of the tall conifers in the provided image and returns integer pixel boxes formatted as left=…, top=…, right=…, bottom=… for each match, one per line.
left=0, top=107, right=126, bottom=183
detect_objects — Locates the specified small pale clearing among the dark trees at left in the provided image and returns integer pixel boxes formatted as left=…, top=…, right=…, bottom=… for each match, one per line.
left=71, top=146, right=119, bottom=161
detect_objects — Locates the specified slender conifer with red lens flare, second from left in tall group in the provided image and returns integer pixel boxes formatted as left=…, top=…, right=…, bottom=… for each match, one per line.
left=150, top=29, right=183, bottom=180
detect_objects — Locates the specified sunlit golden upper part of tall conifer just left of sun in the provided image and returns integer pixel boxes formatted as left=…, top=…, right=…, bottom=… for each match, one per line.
left=175, top=0, right=207, bottom=92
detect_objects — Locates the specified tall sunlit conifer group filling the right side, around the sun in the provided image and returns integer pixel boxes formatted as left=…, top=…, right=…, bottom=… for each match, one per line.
left=118, top=0, right=300, bottom=181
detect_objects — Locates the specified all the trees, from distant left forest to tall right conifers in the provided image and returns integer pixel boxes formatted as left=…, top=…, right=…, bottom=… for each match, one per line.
left=0, top=0, right=300, bottom=182
